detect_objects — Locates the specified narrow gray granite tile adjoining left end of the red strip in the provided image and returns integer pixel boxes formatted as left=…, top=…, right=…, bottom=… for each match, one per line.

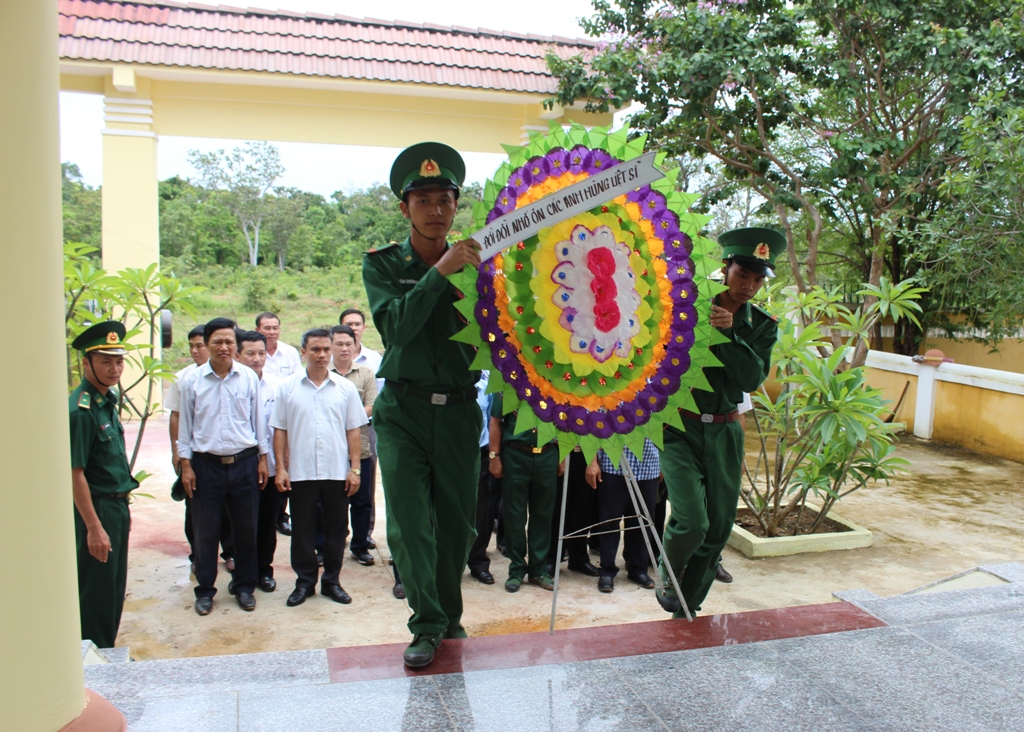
left=85, top=650, right=330, bottom=699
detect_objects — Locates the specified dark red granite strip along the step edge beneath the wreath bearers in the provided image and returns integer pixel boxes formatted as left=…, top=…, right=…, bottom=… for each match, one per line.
left=327, top=602, right=886, bottom=683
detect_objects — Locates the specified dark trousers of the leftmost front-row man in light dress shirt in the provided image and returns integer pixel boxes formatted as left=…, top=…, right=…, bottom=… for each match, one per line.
left=191, top=454, right=259, bottom=597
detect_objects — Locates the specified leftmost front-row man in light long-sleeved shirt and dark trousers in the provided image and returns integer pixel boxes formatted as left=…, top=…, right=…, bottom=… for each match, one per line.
left=178, top=317, right=269, bottom=615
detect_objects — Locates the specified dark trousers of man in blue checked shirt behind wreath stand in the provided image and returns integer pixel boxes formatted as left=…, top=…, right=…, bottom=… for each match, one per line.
left=597, top=471, right=657, bottom=577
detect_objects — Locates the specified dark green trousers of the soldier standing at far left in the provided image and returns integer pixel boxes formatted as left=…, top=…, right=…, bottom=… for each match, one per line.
left=75, top=496, right=131, bottom=648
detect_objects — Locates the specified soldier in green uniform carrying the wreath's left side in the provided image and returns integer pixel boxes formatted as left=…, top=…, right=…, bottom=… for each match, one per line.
left=362, top=142, right=482, bottom=668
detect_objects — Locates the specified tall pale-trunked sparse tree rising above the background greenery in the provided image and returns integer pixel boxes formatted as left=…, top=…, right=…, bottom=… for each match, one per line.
left=188, top=142, right=285, bottom=267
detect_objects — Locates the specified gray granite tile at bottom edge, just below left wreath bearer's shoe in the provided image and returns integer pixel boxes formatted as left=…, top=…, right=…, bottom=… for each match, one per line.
left=239, top=677, right=454, bottom=732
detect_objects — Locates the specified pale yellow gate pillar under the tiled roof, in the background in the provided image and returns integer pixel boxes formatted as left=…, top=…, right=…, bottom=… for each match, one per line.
left=103, top=73, right=160, bottom=273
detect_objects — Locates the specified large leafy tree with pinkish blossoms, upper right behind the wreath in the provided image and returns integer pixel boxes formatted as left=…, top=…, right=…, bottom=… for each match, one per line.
left=548, top=0, right=1024, bottom=360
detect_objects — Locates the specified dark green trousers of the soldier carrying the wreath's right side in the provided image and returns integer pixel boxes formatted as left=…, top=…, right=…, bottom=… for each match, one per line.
left=662, top=420, right=743, bottom=617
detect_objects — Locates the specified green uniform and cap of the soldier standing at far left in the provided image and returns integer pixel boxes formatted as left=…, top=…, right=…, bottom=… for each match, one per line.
left=68, top=322, right=138, bottom=648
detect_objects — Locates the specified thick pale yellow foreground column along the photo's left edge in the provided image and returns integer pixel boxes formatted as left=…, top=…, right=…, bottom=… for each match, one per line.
left=0, top=0, right=85, bottom=732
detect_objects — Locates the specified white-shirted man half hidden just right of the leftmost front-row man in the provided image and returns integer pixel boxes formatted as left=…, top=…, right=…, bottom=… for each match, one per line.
left=238, top=331, right=281, bottom=592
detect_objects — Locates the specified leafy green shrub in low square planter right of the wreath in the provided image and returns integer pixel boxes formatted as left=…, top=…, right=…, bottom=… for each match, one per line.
left=730, top=278, right=924, bottom=556
